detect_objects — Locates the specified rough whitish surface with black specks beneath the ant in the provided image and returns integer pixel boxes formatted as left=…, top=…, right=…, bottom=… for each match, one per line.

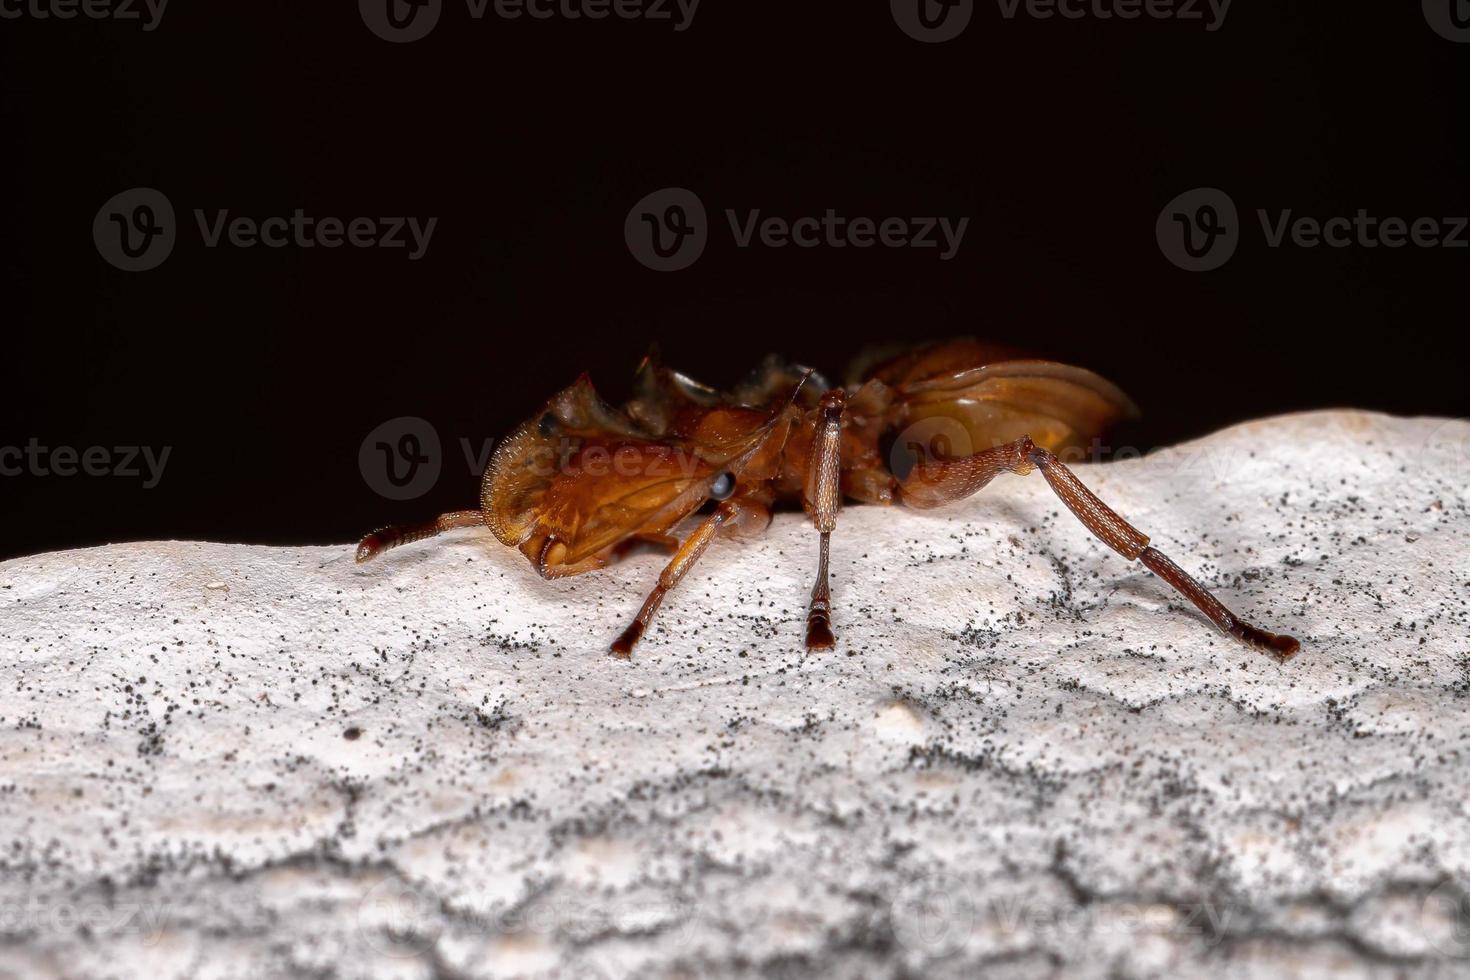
left=0, top=411, right=1470, bottom=980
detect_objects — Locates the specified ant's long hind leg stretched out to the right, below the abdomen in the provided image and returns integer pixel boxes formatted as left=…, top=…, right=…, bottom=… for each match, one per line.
left=901, top=436, right=1301, bottom=661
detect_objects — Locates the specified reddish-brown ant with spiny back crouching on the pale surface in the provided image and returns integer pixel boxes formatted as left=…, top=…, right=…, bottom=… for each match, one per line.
left=357, top=341, right=1299, bottom=661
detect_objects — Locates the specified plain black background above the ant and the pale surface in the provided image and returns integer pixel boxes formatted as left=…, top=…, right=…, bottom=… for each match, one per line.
left=0, top=0, right=1470, bottom=557
